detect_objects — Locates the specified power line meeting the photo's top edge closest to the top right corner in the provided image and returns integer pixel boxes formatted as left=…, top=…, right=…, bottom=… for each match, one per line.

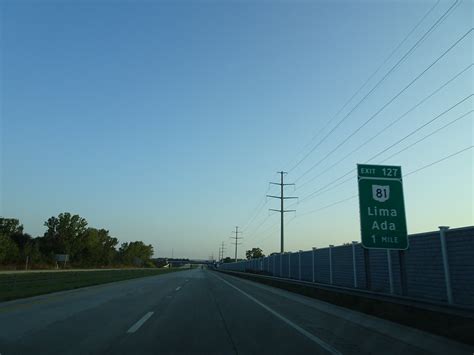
left=291, top=0, right=459, bottom=181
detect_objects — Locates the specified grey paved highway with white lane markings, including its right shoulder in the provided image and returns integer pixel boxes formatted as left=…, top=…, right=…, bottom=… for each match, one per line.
left=0, top=269, right=468, bottom=355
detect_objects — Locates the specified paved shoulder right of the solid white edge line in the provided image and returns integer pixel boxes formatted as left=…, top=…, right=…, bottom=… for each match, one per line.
left=215, top=273, right=474, bottom=354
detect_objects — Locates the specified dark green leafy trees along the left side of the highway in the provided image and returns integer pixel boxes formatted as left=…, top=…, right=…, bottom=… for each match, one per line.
left=0, top=212, right=154, bottom=268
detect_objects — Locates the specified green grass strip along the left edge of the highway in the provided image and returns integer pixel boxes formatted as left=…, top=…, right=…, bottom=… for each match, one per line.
left=0, top=269, right=185, bottom=302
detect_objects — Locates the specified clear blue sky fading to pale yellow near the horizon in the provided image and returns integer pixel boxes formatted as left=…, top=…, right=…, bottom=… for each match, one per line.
left=0, top=0, right=474, bottom=258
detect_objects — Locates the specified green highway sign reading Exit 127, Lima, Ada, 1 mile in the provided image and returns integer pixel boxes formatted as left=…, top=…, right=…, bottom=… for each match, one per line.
left=357, top=164, right=408, bottom=249
